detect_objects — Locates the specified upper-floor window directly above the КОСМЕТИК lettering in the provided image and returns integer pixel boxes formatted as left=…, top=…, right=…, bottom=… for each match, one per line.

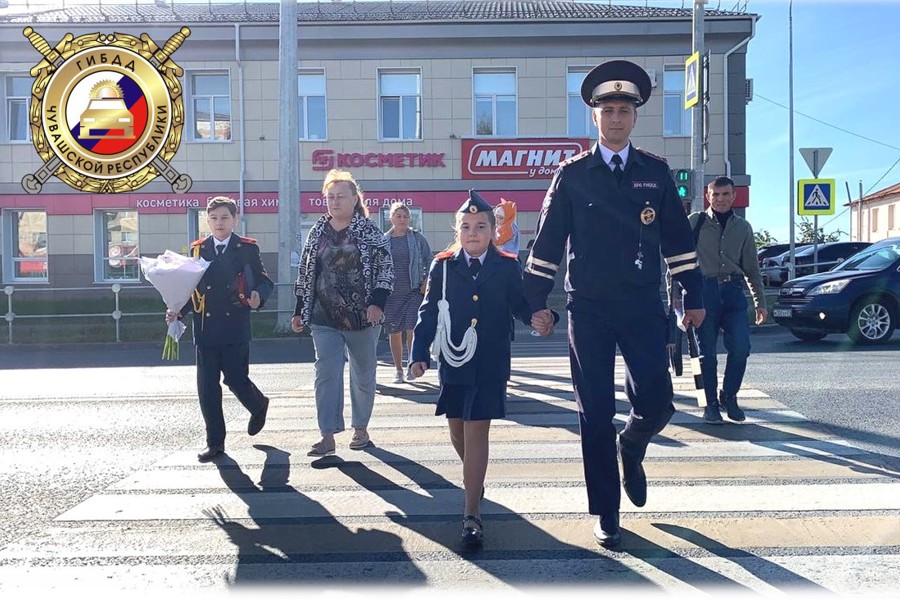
left=378, top=71, right=422, bottom=140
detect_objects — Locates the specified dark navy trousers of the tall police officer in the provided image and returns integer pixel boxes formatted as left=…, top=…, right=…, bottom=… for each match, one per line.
left=569, top=311, right=675, bottom=515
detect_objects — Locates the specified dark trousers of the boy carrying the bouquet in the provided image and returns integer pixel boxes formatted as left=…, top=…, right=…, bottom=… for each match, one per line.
left=197, top=342, right=263, bottom=447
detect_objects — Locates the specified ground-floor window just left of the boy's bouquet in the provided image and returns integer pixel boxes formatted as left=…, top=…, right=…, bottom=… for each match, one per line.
left=94, top=210, right=140, bottom=281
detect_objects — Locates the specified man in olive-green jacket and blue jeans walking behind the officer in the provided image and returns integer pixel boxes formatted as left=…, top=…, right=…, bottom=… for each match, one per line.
left=674, top=177, right=768, bottom=424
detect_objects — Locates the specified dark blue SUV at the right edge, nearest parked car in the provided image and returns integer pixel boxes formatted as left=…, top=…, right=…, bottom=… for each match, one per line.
left=772, top=239, right=900, bottom=344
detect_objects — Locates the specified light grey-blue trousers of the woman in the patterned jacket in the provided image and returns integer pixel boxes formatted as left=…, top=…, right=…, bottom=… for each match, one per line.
left=309, top=324, right=381, bottom=435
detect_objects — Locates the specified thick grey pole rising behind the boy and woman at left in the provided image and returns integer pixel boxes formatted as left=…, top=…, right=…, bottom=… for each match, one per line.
left=275, top=0, right=300, bottom=333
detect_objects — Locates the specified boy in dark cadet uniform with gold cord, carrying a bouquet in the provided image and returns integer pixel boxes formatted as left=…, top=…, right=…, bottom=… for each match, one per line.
left=166, top=196, right=274, bottom=462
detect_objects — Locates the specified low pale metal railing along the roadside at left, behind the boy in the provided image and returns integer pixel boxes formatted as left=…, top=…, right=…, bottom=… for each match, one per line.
left=3, top=283, right=294, bottom=344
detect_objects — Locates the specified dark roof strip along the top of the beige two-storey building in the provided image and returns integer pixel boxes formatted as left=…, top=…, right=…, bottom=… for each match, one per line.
left=0, top=0, right=746, bottom=23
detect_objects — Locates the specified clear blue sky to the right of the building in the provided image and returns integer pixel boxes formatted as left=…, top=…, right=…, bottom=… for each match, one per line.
left=744, top=0, right=900, bottom=242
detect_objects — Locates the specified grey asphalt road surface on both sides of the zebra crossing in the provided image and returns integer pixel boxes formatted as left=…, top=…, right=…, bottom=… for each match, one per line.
left=0, top=326, right=900, bottom=564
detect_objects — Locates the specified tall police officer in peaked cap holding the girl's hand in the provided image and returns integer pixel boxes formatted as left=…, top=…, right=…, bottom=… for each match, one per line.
left=524, top=60, right=705, bottom=546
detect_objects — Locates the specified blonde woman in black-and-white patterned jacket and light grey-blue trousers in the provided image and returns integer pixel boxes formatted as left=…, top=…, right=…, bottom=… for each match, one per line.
left=291, top=169, right=394, bottom=457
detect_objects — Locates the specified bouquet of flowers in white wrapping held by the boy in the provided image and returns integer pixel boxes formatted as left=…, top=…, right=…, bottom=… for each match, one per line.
left=140, top=250, right=209, bottom=360
